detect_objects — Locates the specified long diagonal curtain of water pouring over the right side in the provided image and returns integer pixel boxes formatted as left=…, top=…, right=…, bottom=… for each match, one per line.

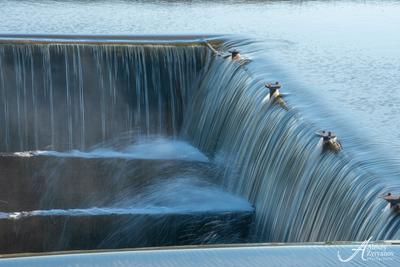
left=184, top=54, right=400, bottom=242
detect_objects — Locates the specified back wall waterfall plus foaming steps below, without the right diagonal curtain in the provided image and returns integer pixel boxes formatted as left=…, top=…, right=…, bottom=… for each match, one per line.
left=0, top=35, right=253, bottom=253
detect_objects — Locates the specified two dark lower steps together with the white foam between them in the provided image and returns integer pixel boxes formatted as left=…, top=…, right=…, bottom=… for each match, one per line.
left=0, top=154, right=253, bottom=253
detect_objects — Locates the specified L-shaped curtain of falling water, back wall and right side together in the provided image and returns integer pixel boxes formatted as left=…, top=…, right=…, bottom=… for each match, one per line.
left=0, top=37, right=400, bottom=247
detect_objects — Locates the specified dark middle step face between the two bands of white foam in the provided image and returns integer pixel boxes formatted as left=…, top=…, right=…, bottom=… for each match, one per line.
left=0, top=154, right=218, bottom=212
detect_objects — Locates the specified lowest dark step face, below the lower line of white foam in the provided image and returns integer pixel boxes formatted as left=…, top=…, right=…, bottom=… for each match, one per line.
left=0, top=210, right=253, bottom=254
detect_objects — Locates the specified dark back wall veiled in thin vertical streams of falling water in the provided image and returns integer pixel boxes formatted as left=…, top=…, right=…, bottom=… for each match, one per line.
left=0, top=44, right=207, bottom=152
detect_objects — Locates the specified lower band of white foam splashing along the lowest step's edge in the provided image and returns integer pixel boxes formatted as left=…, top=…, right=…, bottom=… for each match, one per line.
left=0, top=177, right=253, bottom=220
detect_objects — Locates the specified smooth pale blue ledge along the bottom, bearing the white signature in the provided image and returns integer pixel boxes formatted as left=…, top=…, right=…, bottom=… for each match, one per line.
left=0, top=245, right=400, bottom=267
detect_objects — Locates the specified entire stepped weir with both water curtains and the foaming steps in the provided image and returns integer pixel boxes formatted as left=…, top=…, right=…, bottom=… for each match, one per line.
left=0, top=33, right=400, bottom=265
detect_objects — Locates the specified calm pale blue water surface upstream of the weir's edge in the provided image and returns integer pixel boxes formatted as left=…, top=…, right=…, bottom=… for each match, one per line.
left=0, top=0, right=400, bottom=155
